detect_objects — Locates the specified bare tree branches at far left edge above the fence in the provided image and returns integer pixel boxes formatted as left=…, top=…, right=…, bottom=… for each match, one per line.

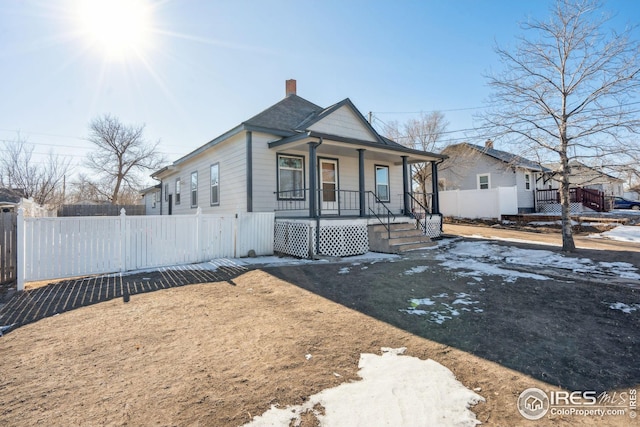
left=0, top=136, right=70, bottom=206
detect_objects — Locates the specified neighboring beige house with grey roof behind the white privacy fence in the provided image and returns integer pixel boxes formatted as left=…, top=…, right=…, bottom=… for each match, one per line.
left=439, top=140, right=551, bottom=213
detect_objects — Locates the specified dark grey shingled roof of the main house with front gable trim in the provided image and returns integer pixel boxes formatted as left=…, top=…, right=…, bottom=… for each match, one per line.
left=151, top=90, right=446, bottom=178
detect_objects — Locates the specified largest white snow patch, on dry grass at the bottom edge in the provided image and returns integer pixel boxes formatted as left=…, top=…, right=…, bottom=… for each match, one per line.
left=245, top=348, right=484, bottom=427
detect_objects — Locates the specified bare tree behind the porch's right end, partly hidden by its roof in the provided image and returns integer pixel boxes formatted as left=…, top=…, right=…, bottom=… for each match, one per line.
left=383, top=111, right=449, bottom=200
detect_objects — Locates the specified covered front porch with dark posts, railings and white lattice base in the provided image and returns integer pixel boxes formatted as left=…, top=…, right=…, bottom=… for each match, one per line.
left=269, top=132, right=442, bottom=258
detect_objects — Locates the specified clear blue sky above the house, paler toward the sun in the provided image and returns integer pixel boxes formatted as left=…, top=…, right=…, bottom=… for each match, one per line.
left=0, top=0, right=640, bottom=182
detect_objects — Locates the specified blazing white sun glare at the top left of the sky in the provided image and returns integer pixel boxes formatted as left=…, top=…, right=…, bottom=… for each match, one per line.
left=76, top=0, right=151, bottom=60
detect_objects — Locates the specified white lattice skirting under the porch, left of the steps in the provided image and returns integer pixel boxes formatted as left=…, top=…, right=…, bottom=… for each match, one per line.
left=273, top=220, right=369, bottom=258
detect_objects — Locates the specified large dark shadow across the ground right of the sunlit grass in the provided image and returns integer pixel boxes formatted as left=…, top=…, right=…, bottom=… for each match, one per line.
left=264, top=241, right=640, bottom=391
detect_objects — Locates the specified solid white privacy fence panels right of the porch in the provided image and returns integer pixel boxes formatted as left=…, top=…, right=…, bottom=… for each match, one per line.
left=439, top=186, right=518, bottom=218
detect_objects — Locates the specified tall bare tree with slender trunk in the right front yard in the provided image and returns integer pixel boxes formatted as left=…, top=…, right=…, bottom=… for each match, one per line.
left=485, top=0, right=640, bottom=251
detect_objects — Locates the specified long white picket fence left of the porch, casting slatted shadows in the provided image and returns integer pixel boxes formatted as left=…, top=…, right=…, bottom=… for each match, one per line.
left=17, top=210, right=274, bottom=290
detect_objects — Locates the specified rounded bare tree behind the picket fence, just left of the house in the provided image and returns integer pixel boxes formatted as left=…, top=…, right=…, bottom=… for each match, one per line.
left=85, top=114, right=164, bottom=204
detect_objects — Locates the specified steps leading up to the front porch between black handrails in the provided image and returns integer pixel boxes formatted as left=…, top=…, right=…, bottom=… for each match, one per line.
left=369, top=222, right=435, bottom=254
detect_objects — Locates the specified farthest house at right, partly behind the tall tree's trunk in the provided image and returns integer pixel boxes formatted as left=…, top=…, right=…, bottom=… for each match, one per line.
left=543, top=160, right=625, bottom=197
